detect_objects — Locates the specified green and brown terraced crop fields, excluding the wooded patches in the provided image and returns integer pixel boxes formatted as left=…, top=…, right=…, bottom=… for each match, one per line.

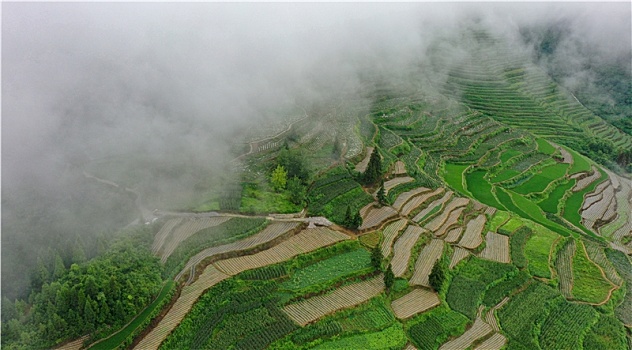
left=117, top=30, right=632, bottom=349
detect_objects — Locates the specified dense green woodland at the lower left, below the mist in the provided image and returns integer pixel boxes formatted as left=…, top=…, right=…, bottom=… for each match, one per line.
left=2, top=226, right=162, bottom=349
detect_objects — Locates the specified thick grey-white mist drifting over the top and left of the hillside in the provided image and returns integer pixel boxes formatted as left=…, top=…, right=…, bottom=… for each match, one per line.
left=2, top=3, right=631, bottom=298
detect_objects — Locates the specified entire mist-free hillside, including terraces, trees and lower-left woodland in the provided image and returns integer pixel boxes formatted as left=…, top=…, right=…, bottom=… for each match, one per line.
left=2, top=2, right=632, bottom=350
